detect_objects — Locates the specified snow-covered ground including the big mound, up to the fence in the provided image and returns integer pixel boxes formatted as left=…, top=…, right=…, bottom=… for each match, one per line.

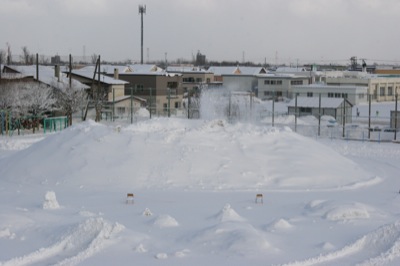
left=0, top=118, right=400, bottom=266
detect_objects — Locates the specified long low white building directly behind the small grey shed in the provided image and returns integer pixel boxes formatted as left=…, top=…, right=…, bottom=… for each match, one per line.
left=292, top=83, right=368, bottom=105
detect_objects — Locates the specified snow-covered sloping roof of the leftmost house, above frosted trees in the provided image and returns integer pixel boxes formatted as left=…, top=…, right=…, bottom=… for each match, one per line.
left=3, top=65, right=89, bottom=89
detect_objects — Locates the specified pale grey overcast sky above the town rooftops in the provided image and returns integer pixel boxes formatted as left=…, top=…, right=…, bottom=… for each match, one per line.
left=0, top=0, right=400, bottom=64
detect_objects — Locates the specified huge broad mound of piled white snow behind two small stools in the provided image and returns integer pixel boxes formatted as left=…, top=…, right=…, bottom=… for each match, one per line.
left=0, top=118, right=379, bottom=190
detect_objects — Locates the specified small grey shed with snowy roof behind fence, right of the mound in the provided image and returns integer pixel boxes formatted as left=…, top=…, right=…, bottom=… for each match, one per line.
left=288, top=97, right=353, bottom=124
